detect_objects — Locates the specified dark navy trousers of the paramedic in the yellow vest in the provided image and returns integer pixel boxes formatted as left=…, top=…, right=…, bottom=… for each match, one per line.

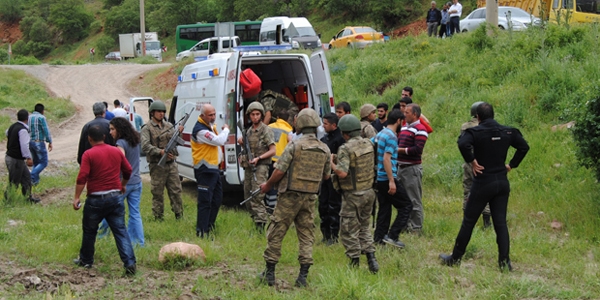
left=194, top=166, right=223, bottom=236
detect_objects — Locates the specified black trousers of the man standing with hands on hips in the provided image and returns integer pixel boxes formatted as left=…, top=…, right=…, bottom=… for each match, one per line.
left=452, top=174, right=510, bottom=262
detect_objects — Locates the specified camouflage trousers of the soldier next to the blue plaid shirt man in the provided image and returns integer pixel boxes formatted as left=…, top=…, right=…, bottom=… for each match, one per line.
left=340, top=189, right=376, bottom=258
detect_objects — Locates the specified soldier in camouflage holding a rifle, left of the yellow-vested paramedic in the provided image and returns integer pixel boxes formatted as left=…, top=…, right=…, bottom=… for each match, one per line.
left=141, top=101, right=183, bottom=220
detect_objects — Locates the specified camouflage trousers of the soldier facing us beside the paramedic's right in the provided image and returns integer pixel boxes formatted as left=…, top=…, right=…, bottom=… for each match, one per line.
left=244, top=165, right=269, bottom=223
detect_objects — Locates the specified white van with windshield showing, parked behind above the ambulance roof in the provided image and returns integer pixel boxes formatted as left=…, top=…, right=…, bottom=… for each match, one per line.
left=260, top=17, right=322, bottom=49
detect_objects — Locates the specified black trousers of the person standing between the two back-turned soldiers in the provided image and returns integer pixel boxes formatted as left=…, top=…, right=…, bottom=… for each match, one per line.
left=319, top=179, right=342, bottom=239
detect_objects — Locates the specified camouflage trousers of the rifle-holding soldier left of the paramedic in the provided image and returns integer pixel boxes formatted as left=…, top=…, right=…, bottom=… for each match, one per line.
left=149, top=162, right=183, bottom=219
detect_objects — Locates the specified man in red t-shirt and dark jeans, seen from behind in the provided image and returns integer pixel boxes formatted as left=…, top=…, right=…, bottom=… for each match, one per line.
left=73, top=125, right=136, bottom=275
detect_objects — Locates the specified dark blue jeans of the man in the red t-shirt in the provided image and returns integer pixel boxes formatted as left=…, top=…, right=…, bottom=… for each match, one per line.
left=79, top=193, right=135, bottom=268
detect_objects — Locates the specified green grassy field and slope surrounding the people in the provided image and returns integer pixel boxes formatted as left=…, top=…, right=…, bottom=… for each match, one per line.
left=0, top=25, right=600, bottom=299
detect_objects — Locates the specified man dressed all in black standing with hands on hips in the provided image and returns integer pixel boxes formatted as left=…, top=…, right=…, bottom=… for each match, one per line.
left=440, top=102, right=529, bottom=271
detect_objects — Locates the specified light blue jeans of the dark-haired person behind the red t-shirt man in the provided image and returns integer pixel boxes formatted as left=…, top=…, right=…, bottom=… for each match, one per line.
left=98, top=182, right=145, bottom=247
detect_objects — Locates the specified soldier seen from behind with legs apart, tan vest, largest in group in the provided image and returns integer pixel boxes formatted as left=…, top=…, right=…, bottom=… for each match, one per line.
left=260, top=108, right=331, bottom=287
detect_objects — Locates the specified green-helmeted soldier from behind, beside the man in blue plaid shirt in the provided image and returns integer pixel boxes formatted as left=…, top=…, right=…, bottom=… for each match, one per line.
left=331, top=115, right=379, bottom=274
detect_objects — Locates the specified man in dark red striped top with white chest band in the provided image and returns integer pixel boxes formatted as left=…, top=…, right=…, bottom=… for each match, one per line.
left=398, top=103, right=427, bottom=233
